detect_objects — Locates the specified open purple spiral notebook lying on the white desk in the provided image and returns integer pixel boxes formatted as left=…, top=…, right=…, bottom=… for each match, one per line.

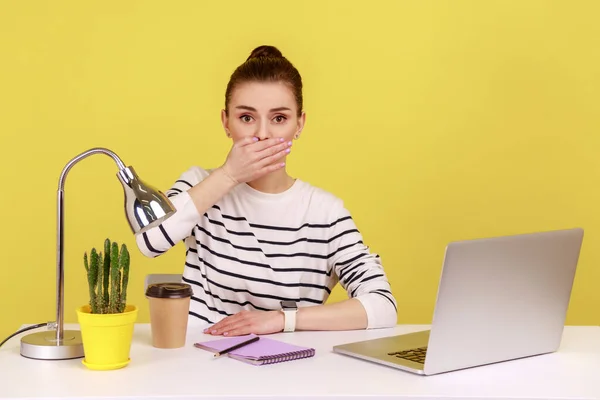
left=194, top=334, right=315, bottom=365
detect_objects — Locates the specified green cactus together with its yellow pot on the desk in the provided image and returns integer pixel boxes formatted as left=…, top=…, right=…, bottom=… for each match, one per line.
left=77, top=239, right=138, bottom=370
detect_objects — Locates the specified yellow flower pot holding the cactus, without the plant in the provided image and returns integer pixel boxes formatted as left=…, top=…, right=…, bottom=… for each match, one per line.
left=76, top=305, right=138, bottom=370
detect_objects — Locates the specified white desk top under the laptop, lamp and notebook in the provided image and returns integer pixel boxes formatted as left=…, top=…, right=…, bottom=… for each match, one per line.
left=0, top=324, right=600, bottom=400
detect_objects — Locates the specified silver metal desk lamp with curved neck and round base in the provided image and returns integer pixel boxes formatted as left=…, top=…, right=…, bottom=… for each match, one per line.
left=21, top=147, right=175, bottom=360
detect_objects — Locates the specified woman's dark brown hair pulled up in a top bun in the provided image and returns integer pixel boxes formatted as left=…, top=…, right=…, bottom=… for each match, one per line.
left=225, top=45, right=302, bottom=116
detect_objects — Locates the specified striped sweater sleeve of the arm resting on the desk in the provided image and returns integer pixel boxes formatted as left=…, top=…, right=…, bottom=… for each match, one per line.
left=329, top=200, right=398, bottom=329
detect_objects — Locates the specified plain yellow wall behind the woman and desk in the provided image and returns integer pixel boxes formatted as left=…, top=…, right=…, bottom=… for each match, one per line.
left=0, top=0, right=600, bottom=337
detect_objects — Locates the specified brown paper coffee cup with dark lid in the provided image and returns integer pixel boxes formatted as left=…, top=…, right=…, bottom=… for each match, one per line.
left=146, top=282, right=193, bottom=349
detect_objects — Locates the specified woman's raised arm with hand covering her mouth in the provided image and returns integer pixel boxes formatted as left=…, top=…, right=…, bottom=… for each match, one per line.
left=136, top=138, right=290, bottom=258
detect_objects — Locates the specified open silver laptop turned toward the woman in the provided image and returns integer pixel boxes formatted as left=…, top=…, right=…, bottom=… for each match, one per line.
left=333, top=228, right=583, bottom=375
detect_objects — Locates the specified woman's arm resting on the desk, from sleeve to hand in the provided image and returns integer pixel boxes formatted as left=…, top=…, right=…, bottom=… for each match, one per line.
left=206, top=199, right=398, bottom=336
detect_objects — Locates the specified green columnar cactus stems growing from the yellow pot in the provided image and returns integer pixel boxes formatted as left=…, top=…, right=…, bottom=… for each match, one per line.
left=83, top=239, right=129, bottom=314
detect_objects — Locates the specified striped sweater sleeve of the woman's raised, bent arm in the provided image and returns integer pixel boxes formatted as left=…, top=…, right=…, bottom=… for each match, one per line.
left=135, top=167, right=208, bottom=258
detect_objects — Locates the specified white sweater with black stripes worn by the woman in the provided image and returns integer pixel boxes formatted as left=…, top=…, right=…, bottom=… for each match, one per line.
left=136, top=167, right=397, bottom=328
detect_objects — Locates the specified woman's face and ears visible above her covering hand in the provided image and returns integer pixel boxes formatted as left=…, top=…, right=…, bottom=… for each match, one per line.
left=221, top=82, right=306, bottom=142
